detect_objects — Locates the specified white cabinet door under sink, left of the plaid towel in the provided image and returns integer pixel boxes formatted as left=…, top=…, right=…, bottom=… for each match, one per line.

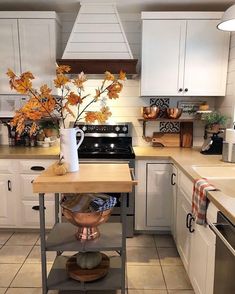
left=176, top=188, right=191, bottom=271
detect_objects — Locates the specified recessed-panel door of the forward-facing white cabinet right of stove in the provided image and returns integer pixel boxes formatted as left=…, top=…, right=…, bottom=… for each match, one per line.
left=146, top=164, right=172, bottom=230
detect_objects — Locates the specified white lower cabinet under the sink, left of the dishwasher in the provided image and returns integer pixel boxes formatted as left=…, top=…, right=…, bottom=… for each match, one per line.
left=176, top=172, right=217, bottom=294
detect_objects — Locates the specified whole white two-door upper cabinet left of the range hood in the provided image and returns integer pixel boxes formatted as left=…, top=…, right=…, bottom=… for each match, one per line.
left=0, top=11, right=59, bottom=94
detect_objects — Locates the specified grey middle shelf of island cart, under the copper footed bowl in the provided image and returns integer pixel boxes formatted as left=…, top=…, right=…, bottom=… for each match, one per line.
left=46, top=223, right=122, bottom=252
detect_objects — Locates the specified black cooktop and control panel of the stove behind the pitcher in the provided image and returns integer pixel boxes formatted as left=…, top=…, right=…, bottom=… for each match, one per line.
left=74, top=123, right=135, bottom=159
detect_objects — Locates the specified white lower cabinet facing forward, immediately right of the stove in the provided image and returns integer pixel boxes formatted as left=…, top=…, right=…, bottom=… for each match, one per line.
left=135, top=160, right=173, bottom=231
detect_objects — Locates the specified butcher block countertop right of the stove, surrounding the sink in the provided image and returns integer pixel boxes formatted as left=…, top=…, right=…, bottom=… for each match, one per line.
left=134, top=147, right=235, bottom=224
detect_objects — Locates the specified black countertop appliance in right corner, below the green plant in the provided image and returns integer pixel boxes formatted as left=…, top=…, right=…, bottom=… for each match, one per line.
left=201, top=131, right=223, bottom=154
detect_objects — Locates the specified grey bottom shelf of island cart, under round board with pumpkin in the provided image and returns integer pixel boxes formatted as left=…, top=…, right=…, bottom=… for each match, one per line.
left=47, top=256, right=122, bottom=291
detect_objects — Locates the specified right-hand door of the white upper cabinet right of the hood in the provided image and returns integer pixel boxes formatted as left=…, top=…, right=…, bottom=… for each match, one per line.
left=184, top=20, right=229, bottom=96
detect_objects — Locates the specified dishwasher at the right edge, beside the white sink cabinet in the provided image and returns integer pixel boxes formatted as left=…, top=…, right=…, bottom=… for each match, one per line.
left=210, top=212, right=235, bottom=294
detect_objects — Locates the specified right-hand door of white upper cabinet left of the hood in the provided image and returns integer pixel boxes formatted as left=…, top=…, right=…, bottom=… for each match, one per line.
left=19, top=19, right=56, bottom=87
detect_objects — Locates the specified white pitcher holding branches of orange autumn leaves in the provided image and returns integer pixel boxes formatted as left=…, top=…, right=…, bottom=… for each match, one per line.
left=7, top=65, right=126, bottom=172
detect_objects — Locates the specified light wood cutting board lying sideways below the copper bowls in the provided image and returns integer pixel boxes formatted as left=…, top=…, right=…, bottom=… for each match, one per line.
left=152, top=132, right=180, bottom=147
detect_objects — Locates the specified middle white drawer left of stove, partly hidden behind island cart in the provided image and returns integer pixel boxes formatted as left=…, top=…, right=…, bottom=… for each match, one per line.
left=20, top=174, right=54, bottom=200
